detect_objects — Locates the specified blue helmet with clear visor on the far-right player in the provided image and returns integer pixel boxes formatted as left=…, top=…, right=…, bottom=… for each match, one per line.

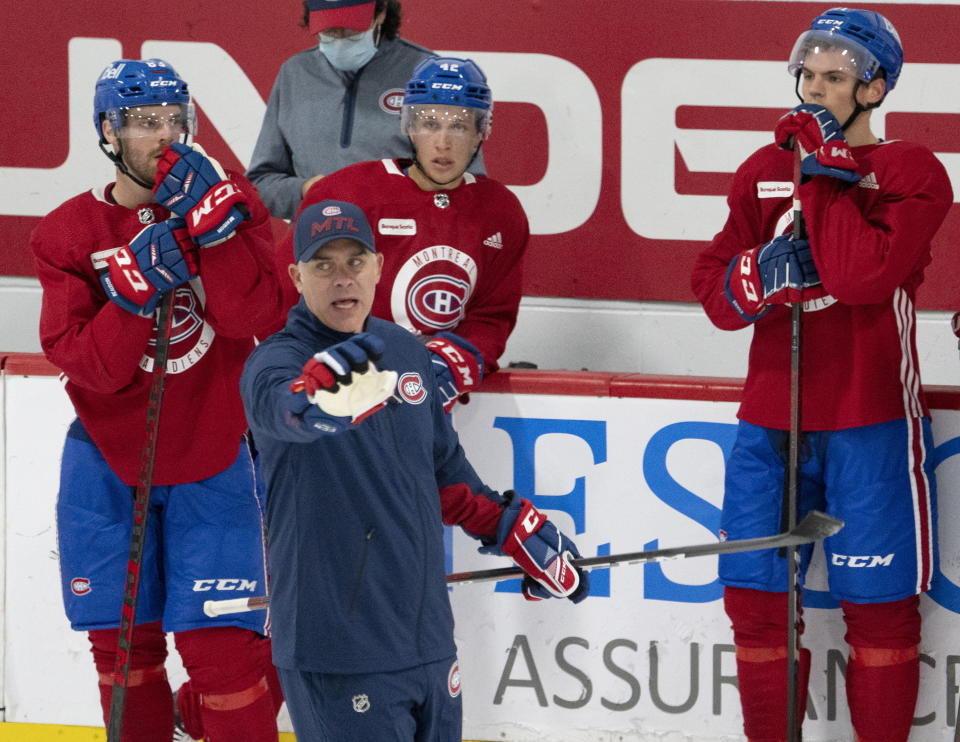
left=787, top=8, right=903, bottom=91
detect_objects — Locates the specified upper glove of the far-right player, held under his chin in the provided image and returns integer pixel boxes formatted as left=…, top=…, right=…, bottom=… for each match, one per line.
left=773, top=103, right=861, bottom=183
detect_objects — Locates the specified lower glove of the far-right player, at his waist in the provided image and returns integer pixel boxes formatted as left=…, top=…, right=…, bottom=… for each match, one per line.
left=724, top=234, right=826, bottom=322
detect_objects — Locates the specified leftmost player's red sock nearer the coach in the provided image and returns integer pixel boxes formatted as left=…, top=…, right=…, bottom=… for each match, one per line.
left=174, top=626, right=282, bottom=742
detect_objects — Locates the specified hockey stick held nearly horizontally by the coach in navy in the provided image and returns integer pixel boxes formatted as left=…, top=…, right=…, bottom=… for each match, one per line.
left=203, top=510, right=843, bottom=617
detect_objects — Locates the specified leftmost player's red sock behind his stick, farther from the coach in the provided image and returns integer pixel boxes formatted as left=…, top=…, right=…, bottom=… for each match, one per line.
left=87, top=622, right=173, bottom=742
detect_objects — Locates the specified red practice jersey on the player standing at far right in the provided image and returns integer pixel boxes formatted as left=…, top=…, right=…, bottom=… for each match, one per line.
left=692, top=141, right=953, bottom=430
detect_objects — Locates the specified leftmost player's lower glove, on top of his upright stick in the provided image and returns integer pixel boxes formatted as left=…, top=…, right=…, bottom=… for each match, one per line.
left=100, top=217, right=198, bottom=317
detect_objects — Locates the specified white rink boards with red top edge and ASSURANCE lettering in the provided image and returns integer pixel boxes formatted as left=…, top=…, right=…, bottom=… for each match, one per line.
left=0, top=356, right=960, bottom=742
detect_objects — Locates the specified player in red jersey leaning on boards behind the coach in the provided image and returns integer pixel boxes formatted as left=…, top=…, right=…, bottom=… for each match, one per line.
left=278, top=57, right=529, bottom=411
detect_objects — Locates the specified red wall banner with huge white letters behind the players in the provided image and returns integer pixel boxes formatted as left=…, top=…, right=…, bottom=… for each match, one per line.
left=0, top=0, right=960, bottom=310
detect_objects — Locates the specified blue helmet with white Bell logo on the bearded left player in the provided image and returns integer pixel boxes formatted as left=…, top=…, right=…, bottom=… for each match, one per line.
left=93, top=59, right=196, bottom=142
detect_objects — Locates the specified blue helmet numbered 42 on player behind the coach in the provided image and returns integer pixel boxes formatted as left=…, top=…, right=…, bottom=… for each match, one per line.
left=400, top=57, right=493, bottom=137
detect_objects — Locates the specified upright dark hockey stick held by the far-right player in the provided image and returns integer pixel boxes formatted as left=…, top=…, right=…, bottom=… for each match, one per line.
left=783, top=148, right=807, bottom=742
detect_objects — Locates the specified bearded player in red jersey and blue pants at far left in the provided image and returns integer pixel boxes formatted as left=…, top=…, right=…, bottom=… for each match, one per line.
left=31, top=59, right=281, bottom=742
